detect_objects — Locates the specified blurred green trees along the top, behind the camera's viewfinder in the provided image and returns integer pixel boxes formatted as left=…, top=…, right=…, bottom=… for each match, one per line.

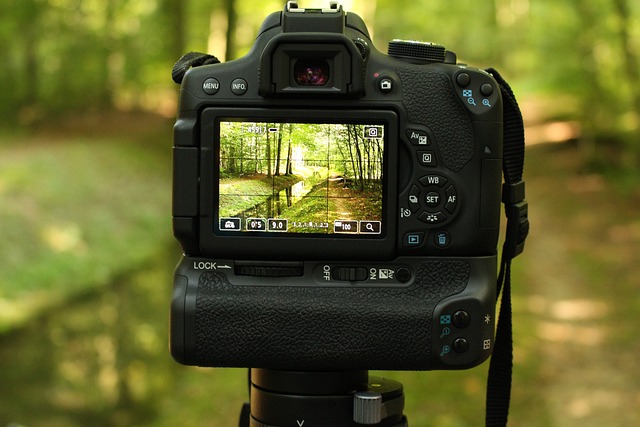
left=0, top=0, right=640, bottom=150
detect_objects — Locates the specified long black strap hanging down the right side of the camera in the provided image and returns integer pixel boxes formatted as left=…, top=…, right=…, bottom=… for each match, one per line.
left=485, top=68, right=529, bottom=427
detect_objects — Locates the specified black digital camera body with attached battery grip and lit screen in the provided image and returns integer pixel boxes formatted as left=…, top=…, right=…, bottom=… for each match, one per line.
left=170, top=2, right=503, bottom=371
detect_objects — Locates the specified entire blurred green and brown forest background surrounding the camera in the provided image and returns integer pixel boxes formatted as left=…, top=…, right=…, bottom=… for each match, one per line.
left=0, top=0, right=640, bottom=427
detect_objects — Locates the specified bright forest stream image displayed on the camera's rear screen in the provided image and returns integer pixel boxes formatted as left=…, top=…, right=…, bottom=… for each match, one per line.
left=218, top=121, right=384, bottom=235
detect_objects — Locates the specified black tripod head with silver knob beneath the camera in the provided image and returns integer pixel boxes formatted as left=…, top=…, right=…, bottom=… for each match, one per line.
left=239, top=369, right=408, bottom=427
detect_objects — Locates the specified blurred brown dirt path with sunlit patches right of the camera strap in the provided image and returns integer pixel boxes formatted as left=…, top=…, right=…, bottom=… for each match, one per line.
left=511, top=145, right=640, bottom=427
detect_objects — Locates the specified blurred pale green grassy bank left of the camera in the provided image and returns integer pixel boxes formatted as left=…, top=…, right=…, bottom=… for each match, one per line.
left=0, top=127, right=171, bottom=331
